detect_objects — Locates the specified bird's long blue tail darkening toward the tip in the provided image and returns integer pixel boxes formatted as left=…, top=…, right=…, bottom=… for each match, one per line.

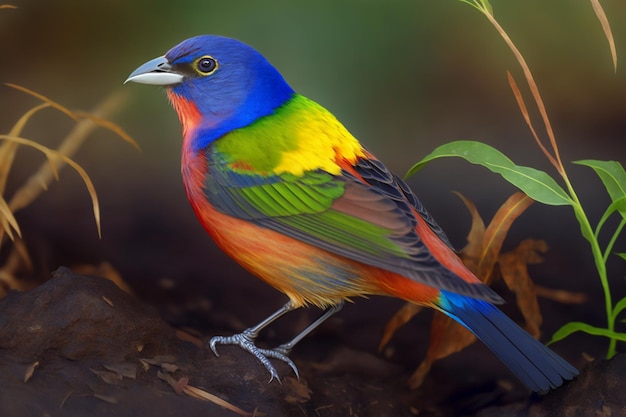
left=438, top=290, right=578, bottom=392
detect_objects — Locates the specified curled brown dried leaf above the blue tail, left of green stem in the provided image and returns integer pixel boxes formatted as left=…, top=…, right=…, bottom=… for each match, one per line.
left=498, top=239, right=548, bottom=338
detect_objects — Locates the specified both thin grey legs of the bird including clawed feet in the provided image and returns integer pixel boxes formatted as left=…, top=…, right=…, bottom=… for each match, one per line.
left=209, top=301, right=343, bottom=382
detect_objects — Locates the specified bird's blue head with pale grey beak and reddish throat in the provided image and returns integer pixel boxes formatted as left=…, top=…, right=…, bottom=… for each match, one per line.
left=126, top=35, right=294, bottom=150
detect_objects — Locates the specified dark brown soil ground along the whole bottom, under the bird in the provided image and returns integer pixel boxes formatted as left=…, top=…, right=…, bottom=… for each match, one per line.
left=0, top=268, right=626, bottom=417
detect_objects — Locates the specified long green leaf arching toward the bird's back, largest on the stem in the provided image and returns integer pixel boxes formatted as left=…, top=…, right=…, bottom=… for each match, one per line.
left=406, top=140, right=573, bottom=206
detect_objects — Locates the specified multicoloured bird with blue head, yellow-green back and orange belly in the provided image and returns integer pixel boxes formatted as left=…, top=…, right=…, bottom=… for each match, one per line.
left=125, top=35, right=578, bottom=392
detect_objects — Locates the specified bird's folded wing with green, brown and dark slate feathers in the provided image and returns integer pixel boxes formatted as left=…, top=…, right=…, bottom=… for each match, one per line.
left=205, top=150, right=501, bottom=302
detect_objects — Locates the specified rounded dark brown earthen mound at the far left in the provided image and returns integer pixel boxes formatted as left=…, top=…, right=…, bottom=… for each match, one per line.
left=0, top=267, right=174, bottom=361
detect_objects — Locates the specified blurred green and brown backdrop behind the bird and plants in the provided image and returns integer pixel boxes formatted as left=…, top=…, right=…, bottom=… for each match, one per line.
left=0, top=0, right=626, bottom=348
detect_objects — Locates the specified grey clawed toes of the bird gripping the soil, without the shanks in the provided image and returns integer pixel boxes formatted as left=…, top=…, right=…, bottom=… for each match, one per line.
left=209, top=329, right=300, bottom=382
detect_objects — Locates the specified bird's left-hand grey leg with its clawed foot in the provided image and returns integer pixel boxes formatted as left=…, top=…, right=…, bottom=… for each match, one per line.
left=209, top=301, right=300, bottom=382
